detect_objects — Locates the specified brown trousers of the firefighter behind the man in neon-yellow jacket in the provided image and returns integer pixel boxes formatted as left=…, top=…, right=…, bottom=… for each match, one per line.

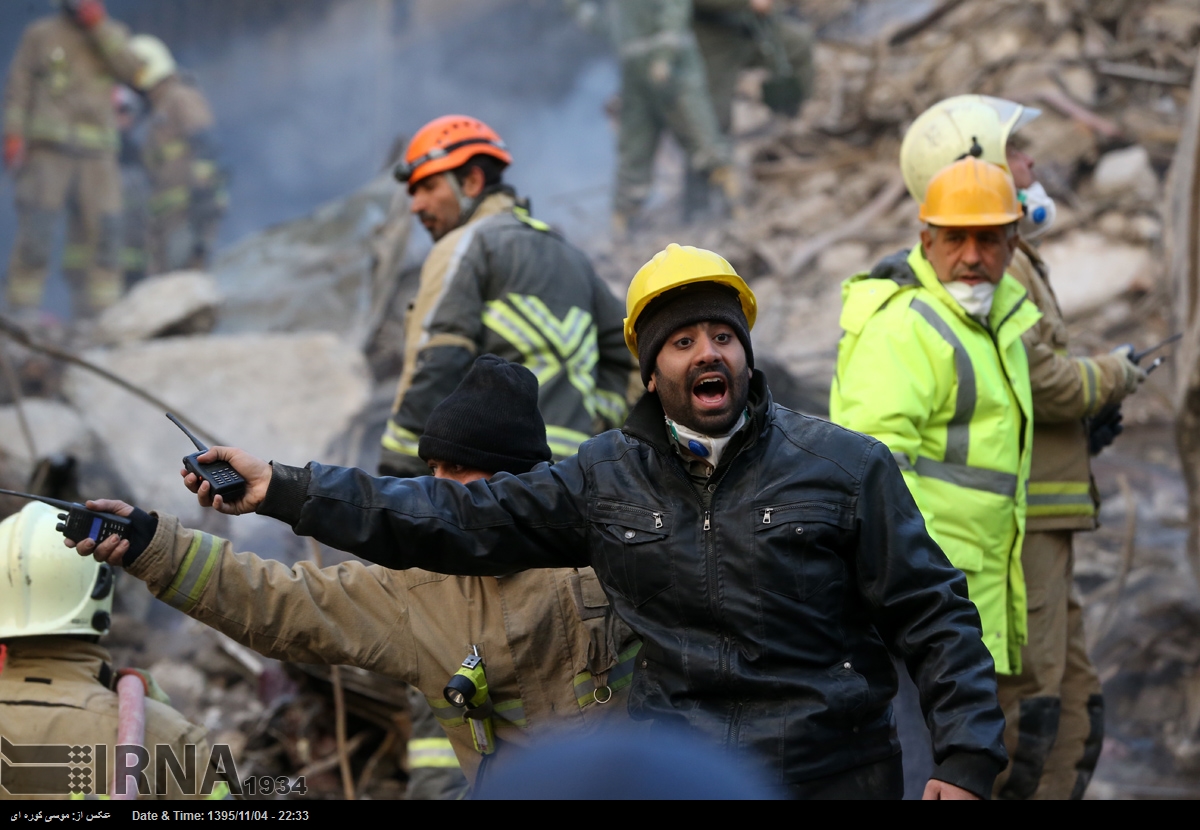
left=994, top=530, right=1104, bottom=800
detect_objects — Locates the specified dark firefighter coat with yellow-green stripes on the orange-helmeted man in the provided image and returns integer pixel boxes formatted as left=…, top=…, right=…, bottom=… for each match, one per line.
left=380, top=188, right=632, bottom=475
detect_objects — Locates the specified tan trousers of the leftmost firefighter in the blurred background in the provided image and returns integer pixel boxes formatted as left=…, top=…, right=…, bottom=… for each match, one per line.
left=7, top=145, right=122, bottom=317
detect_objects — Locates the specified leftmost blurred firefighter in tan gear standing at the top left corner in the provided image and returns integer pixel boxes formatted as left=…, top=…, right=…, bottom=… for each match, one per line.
left=4, top=0, right=142, bottom=319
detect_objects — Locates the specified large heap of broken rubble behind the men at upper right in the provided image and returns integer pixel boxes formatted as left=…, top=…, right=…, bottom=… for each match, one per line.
left=590, top=0, right=1200, bottom=421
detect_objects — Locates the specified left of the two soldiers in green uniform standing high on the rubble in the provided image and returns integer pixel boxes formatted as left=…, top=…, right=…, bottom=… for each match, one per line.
left=612, top=0, right=737, bottom=236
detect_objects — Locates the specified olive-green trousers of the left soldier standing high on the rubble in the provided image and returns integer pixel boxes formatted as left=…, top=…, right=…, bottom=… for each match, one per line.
left=613, top=44, right=731, bottom=216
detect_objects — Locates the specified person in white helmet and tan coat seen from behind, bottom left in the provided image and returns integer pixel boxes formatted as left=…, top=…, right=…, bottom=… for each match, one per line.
left=0, top=501, right=223, bottom=800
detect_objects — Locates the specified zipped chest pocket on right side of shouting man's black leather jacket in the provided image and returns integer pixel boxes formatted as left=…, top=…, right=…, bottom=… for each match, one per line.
left=752, top=501, right=853, bottom=602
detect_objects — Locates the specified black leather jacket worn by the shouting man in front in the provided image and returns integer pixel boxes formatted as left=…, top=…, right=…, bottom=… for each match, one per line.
left=259, top=373, right=1007, bottom=796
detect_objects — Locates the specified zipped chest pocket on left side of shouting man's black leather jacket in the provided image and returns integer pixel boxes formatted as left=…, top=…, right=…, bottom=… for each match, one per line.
left=588, top=499, right=671, bottom=606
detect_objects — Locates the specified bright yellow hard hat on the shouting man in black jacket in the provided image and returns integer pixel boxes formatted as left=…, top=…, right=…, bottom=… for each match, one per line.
left=625, top=242, right=758, bottom=357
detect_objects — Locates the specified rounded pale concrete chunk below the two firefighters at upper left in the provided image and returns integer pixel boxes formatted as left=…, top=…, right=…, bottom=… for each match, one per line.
left=94, top=271, right=221, bottom=345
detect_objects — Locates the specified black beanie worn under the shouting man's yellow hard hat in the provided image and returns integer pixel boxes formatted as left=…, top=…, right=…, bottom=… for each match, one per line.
left=636, top=282, right=754, bottom=385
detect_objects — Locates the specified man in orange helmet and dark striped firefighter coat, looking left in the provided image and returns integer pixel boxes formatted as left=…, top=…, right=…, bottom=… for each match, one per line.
left=379, top=115, right=632, bottom=476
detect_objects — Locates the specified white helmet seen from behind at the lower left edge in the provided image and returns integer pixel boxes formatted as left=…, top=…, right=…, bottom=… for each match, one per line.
left=0, top=501, right=113, bottom=639
